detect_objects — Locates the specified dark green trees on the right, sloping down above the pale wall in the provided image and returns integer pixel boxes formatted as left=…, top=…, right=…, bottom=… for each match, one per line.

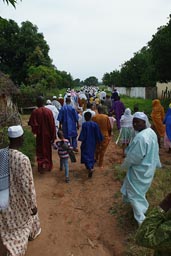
left=102, top=15, right=171, bottom=87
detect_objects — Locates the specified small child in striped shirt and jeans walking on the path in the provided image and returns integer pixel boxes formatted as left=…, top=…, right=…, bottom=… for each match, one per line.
left=54, top=130, right=72, bottom=183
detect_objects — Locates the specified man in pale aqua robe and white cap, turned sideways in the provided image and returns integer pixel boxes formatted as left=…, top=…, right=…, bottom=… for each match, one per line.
left=121, top=112, right=161, bottom=225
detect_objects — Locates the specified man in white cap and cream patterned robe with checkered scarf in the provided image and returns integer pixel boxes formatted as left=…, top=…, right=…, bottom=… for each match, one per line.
left=0, top=125, right=41, bottom=256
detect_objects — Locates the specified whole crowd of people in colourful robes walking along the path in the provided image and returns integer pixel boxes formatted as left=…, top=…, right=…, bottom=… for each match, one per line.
left=0, top=86, right=171, bottom=256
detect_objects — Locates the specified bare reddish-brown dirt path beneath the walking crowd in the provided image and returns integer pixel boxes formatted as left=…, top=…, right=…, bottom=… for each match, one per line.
left=26, top=131, right=168, bottom=256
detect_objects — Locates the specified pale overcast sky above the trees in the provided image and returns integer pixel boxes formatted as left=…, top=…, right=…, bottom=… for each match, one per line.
left=0, top=0, right=171, bottom=80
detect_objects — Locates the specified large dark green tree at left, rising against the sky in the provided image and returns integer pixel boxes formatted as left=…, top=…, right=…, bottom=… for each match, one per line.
left=0, top=18, right=52, bottom=85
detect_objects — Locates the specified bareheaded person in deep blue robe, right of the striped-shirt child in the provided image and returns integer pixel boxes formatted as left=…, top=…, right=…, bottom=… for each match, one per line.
left=78, top=111, right=103, bottom=178
